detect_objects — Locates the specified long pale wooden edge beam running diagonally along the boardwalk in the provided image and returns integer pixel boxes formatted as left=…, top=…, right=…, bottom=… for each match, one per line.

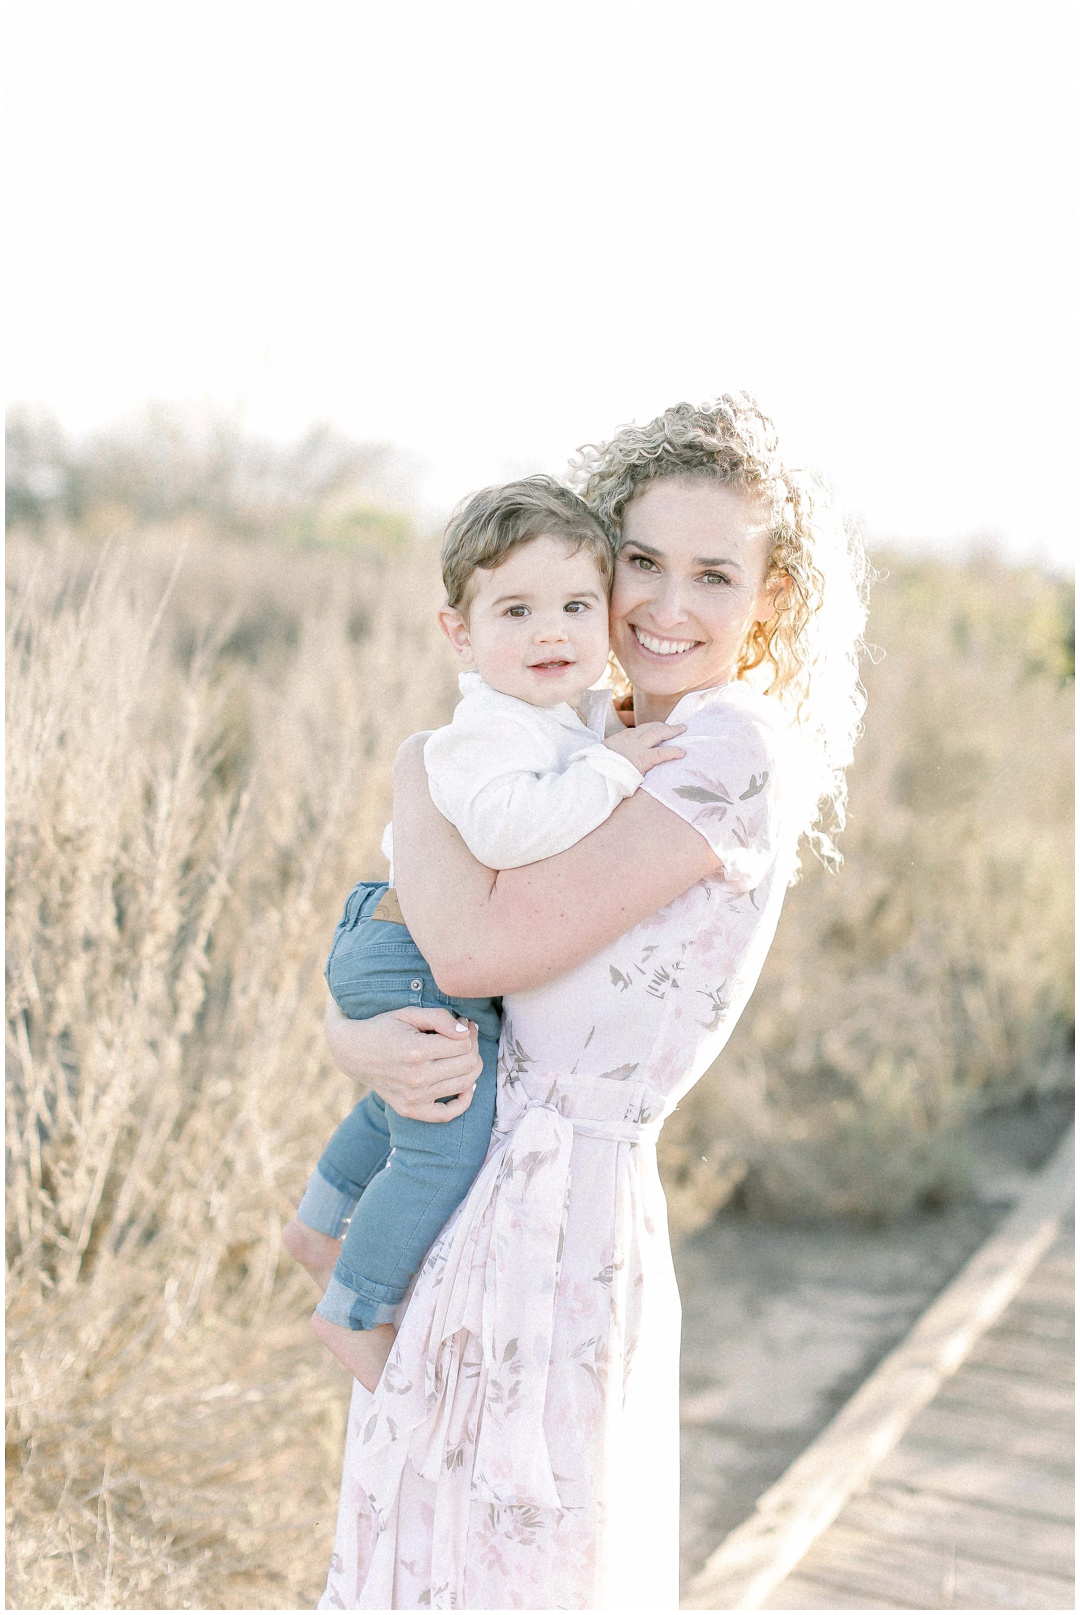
left=683, top=1132, right=1074, bottom=1609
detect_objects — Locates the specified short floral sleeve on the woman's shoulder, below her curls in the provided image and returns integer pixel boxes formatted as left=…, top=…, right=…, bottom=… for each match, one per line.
left=641, top=685, right=785, bottom=891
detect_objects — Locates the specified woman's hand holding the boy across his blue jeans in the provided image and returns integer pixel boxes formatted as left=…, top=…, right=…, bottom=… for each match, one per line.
left=323, top=1003, right=483, bottom=1121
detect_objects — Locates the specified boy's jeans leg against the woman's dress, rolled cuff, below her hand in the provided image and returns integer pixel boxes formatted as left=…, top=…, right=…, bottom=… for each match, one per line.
left=311, top=1019, right=499, bottom=1331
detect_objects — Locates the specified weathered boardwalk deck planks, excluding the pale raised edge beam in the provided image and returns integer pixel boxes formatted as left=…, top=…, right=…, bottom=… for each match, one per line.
left=760, top=1227, right=1074, bottom=1610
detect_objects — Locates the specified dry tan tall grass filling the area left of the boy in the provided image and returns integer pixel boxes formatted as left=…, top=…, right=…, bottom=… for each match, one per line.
left=8, top=529, right=452, bottom=1609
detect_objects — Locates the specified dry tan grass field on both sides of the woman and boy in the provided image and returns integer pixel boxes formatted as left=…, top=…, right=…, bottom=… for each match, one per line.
left=8, top=535, right=1072, bottom=1609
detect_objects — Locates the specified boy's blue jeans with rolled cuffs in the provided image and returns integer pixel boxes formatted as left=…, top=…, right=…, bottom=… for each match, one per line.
left=297, top=880, right=502, bottom=1329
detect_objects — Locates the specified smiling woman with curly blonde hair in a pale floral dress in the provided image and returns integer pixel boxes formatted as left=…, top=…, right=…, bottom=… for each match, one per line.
left=321, top=396, right=865, bottom=1610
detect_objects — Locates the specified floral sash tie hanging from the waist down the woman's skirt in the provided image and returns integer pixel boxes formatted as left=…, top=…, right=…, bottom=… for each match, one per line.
left=355, top=1090, right=660, bottom=1524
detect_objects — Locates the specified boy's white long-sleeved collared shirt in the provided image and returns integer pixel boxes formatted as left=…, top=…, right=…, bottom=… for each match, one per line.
left=383, top=672, right=643, bottom=879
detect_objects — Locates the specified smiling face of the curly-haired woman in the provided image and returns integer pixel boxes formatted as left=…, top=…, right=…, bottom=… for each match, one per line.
left=612, top=476, right=775, bottom=722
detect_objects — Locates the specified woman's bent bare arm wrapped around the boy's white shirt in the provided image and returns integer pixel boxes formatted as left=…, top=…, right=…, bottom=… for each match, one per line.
left=394, top=735, right=720, bottom=998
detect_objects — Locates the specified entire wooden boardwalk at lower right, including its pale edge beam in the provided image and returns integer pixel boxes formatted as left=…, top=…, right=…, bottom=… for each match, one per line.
left=683, top=1135, right=1074, bottom=1610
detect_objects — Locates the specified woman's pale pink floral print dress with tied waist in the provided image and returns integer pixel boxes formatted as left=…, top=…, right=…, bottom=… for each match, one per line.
left=320, top=683, right=794, bottom=1610
